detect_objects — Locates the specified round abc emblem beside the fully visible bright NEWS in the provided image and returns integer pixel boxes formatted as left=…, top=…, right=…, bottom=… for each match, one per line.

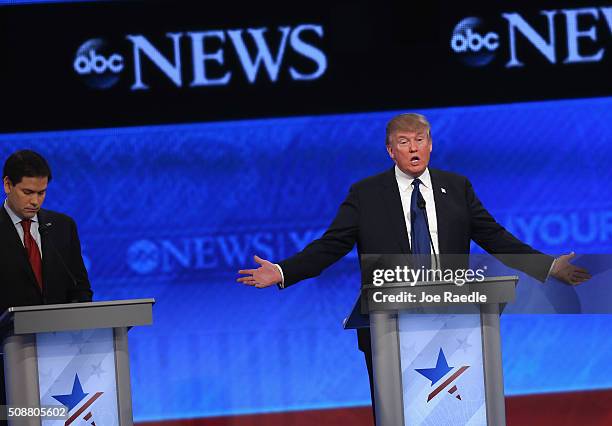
left=72, top=38, right=125, bottom=89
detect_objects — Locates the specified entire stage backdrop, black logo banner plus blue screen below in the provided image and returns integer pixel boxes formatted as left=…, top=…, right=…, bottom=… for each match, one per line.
left=0, top=0, right=612, bottom=421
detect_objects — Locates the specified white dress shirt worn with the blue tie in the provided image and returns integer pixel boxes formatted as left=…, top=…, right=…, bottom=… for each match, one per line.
left=395, top=166, right=440, bottom=254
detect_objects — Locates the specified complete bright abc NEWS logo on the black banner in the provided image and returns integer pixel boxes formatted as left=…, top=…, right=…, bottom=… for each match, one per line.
left=73, top=24, right=327, bottom=90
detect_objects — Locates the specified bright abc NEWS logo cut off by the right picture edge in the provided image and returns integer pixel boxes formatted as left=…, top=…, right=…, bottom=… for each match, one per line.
left=450, top=7, right=612, bottom=67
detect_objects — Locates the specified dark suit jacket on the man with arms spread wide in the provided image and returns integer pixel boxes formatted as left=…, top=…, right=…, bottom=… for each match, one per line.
left=279, top=168, right=553, bottom=287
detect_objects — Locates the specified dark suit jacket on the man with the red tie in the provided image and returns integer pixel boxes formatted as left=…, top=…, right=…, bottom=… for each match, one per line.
left=0, top=205, right=92, bottom=314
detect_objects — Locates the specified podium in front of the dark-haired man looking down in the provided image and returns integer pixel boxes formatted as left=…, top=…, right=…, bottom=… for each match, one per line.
left=0, top=299, right=155, bottom=426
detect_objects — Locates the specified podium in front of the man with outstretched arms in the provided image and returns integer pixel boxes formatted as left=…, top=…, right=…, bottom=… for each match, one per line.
left=344, top=276, right=518, bottom=426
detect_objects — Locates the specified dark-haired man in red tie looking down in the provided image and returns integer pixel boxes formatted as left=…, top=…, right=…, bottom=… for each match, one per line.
left=0, top=150, right=92, bottom=412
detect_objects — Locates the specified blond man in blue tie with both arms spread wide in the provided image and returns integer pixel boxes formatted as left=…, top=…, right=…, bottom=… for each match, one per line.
left=238, top=114, right=590, bottom=418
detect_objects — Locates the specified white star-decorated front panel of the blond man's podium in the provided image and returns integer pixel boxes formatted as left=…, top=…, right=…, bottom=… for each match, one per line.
left=398, top=307, right=487, bottom=426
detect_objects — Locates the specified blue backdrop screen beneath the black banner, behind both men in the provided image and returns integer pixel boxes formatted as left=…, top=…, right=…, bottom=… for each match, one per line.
left=0, top=98, right=612, bottom=420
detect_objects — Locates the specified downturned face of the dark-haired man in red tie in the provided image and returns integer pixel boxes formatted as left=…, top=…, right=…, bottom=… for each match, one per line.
left=4, top=177, right=49, bottom=219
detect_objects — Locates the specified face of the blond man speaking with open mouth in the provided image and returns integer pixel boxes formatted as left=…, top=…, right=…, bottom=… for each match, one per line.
left=387, top=129, right=432, bottom=178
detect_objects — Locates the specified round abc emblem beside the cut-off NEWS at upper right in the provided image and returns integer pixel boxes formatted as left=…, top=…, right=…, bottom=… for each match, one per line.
left=450, top=16, right=499, bottom=67
